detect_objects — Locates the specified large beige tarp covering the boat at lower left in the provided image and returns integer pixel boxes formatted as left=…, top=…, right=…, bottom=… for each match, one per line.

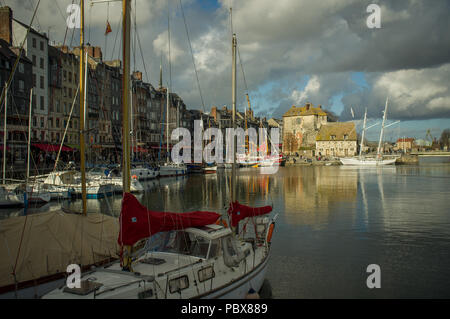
left=0, top=211, right=119, bottom=288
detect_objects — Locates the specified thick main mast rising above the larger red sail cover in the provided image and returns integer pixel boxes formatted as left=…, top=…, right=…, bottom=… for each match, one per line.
left=122, top=0, right=131, bottom=193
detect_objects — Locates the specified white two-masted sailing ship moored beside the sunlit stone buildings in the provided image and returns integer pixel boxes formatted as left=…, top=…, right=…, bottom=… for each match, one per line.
left=340, top=98, right=398, bottom=166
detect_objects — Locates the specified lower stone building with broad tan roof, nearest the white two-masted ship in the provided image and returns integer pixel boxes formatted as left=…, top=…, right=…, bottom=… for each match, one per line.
left=315, top=122, right=357, bottom=157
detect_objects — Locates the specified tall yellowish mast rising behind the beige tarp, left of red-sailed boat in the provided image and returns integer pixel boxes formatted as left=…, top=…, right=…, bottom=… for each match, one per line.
left=79, top=0, right=87, bottom=215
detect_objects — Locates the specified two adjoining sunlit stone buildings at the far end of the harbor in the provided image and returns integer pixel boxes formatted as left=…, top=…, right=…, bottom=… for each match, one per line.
left=282, top=102, right=357, bottom=157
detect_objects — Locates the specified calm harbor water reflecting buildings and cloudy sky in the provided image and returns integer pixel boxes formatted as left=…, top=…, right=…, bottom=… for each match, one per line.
left=0, top=157, right=450, bottom=298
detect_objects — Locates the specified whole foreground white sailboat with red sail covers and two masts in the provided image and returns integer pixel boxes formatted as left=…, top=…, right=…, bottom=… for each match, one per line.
left=44, top=0, right=276, bottom=299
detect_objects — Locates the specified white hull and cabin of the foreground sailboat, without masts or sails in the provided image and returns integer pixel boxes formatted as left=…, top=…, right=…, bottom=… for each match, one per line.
left=43, top=195, right=274, bottom=299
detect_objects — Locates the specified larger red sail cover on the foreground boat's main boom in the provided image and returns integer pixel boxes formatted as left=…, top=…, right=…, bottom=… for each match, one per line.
left=118, top=193, right=220, bottom=246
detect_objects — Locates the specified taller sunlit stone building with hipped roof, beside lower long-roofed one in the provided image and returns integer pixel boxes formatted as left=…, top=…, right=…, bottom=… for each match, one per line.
left=283, top=103, right=327, bottom=154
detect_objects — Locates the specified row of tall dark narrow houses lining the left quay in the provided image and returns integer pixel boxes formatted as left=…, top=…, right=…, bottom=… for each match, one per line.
left=0, top=7, right=280, bottom=168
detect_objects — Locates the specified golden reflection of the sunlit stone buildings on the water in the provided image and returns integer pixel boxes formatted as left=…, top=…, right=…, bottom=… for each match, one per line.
left=283, top=167, right=358, bottom=225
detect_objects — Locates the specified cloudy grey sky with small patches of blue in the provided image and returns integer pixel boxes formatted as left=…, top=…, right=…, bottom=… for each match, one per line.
left=7, top=0, right=450, bottom=140
